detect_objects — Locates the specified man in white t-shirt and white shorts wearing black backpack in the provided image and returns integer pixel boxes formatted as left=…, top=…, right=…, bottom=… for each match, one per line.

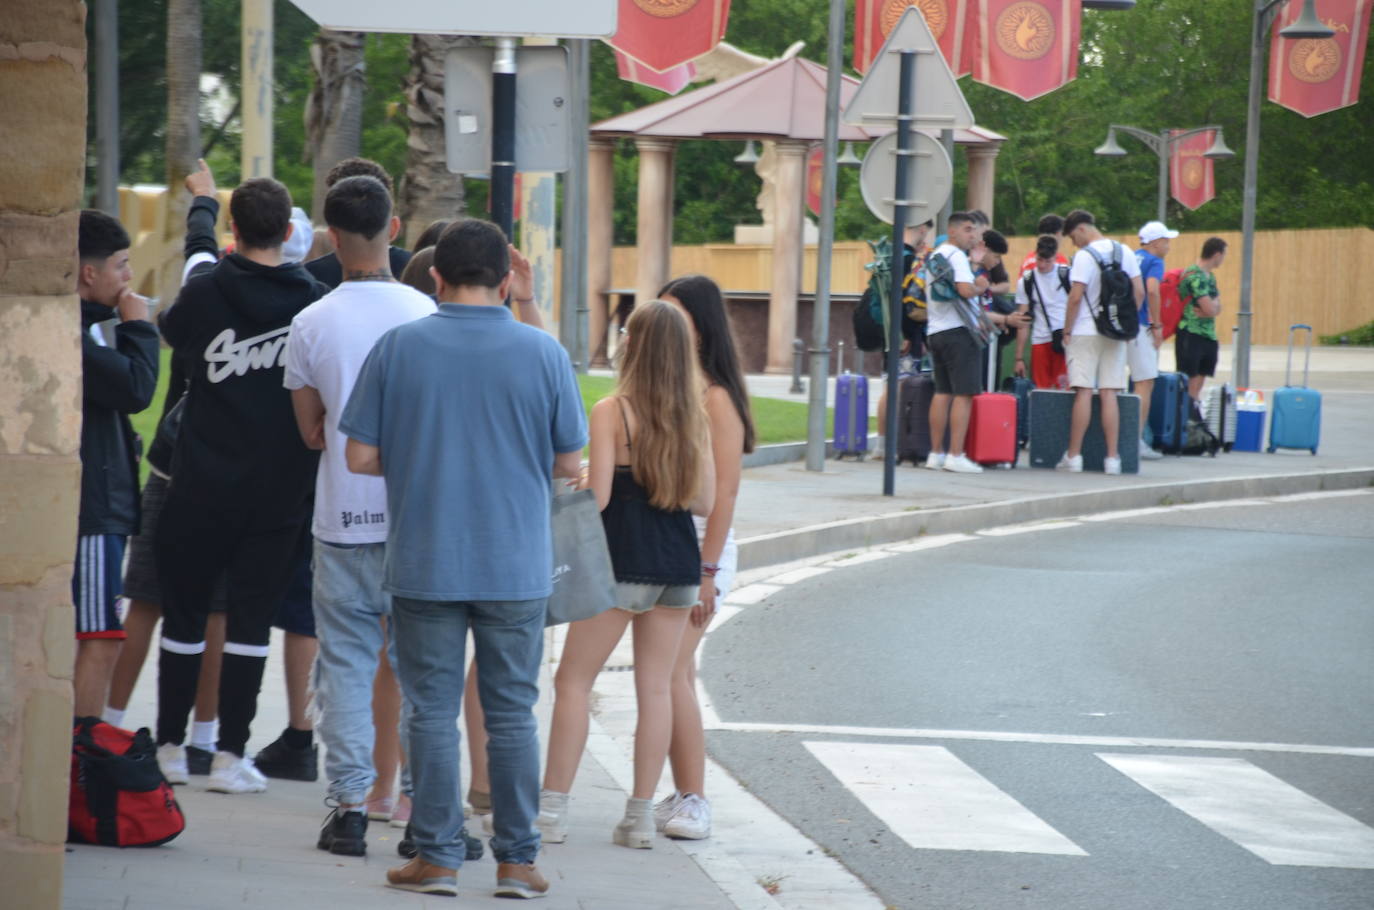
left=1058, top=209, right=1145, bottom=474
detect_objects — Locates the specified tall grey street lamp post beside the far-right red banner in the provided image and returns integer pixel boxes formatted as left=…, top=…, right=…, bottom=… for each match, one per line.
left=1232, top=0, right=1334, bottom=389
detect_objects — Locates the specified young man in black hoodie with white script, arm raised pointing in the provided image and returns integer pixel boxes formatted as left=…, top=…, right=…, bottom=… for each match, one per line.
left=155, top=177, right=327, bottom=793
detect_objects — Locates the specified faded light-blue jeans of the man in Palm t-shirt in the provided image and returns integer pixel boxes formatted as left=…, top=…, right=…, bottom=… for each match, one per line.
left=313, top=540, right=404, bottom=806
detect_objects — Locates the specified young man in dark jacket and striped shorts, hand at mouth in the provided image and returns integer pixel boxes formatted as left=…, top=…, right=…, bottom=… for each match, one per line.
left=71, top=210, right=158, bottom=718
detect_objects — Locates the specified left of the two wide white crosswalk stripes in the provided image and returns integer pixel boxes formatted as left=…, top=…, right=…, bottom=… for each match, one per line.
left=802, top=741, right=1087, bottom=856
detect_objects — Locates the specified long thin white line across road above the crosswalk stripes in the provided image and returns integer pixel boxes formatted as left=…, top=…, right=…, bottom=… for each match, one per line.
left=706, top=720, right=1374, bottom=759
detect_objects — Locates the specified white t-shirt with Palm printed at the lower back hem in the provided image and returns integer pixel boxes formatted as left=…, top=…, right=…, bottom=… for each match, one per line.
left=283, top=282, right=434, bottom=543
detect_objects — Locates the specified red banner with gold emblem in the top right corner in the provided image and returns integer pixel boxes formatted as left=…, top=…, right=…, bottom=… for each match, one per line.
left=1270, top=0, right=1374, bottom=117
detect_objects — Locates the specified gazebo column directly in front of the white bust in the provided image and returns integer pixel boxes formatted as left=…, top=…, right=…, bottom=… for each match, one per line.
left=765, top=142, right=807, bottom=373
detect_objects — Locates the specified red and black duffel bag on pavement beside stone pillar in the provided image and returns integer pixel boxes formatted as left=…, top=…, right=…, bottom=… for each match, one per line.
left=67, top=718, right=185, bottom=847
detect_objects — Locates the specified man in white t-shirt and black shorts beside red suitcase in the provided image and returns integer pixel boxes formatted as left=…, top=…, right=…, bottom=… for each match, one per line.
left=926, top=212, right=988, bottom=474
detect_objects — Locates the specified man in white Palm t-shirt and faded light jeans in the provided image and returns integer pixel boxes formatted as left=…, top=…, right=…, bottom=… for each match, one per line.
left=284, top=176, right=434, bottom=856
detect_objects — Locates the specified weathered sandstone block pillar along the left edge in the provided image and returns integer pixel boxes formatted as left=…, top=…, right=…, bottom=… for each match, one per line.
left=0, top=0, right=87, bottom=910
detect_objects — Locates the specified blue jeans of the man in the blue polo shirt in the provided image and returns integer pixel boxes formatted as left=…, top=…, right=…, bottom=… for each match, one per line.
left=392, top=597, right=545, bottom=869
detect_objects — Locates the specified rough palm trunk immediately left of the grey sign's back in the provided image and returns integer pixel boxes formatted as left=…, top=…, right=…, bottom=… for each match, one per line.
left=400, top=34, right=473, bottom=246
